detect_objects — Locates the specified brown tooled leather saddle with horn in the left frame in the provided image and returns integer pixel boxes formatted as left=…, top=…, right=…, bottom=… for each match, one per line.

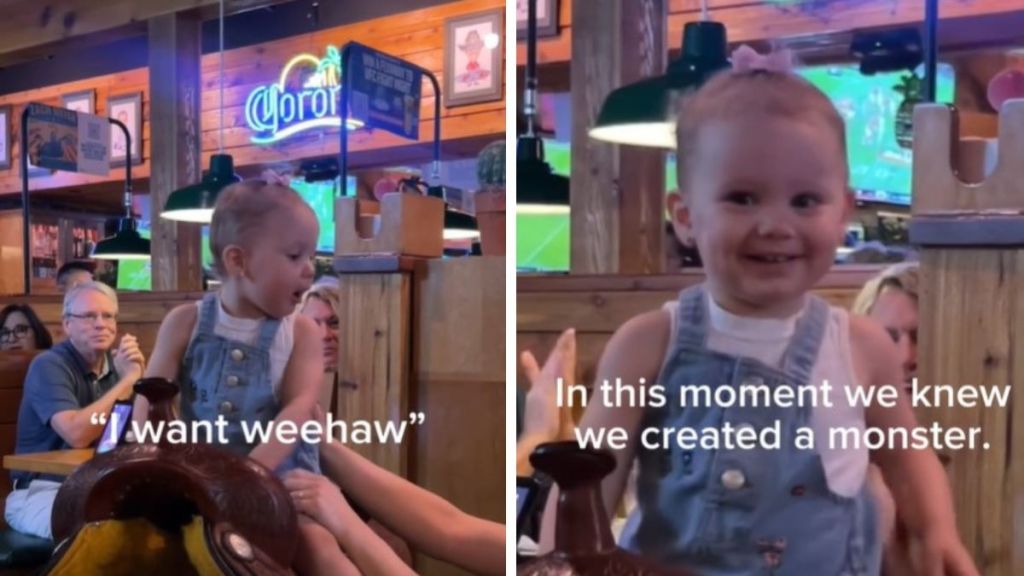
left=52, top=378, right=298, bottom=575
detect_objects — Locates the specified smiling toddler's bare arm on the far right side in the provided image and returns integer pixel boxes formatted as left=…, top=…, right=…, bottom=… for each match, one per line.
left=850, top=317, right=978, bottom=576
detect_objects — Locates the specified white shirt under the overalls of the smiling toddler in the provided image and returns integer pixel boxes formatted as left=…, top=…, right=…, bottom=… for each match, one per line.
left=665, top=296, right=869, bottom=497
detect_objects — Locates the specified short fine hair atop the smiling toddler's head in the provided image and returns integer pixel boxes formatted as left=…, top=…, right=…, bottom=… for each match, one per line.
left=676, top=70, right=850, bottom=191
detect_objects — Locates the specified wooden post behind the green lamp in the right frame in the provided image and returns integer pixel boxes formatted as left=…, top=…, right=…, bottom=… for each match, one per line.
left=570, top=0, right=667, bottom=274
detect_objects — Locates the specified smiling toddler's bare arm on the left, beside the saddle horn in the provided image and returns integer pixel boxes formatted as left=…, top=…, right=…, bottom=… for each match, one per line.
left=539, top=311, right=671, bottom=553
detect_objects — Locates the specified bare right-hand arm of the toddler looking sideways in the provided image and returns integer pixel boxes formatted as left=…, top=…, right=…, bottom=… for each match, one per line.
left=249, top=315, right=324, bottom=470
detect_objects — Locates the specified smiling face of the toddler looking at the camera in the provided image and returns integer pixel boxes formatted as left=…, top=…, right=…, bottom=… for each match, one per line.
left=674, top=115, right=853, bottom=315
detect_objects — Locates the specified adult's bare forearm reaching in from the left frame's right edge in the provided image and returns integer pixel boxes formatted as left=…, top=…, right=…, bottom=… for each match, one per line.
left=321, top=434, right=505, bottom=575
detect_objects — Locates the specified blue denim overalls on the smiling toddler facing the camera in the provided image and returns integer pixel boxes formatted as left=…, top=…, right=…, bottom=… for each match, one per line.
left=621, top=286, right=881, bottom=576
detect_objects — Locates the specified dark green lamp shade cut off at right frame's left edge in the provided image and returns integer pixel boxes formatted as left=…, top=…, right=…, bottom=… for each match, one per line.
left=516, top=135, right=569, bottom=214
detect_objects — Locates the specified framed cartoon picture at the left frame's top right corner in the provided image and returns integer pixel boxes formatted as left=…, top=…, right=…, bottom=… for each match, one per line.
left=444, top=9, right=505, bottom=108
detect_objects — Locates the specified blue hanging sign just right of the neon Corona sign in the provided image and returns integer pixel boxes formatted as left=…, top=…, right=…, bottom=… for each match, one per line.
left=346, top=44, right=423, bottom=140
